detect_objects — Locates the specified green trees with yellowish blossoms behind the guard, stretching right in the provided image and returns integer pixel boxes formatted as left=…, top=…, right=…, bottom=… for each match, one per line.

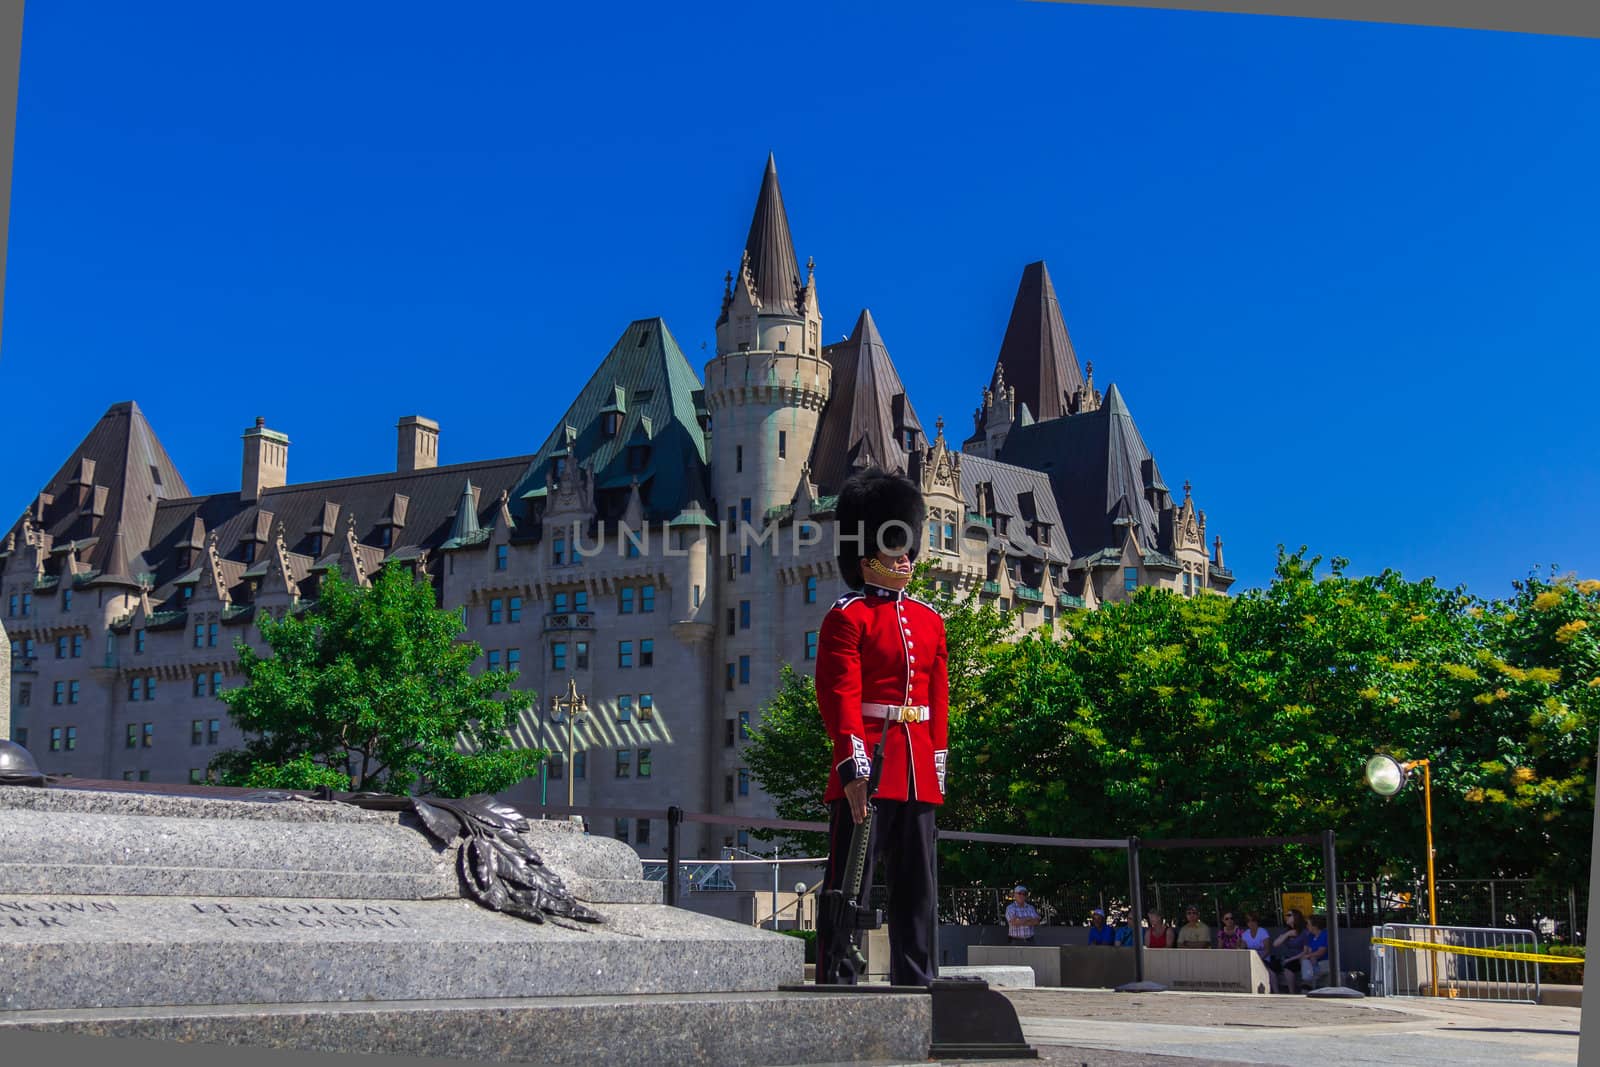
left=752, top=549, right=1600, bottom=888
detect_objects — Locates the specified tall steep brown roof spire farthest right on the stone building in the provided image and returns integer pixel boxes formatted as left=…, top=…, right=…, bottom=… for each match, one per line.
left=995, top=259, right=1083, bottom=422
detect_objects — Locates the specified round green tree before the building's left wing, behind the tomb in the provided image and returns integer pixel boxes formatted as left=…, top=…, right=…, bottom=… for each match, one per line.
left=211, top=568, right=546, bottom=797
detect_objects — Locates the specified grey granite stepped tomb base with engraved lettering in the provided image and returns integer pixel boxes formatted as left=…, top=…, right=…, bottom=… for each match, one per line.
left=0, top=787, right=931, bottom=1064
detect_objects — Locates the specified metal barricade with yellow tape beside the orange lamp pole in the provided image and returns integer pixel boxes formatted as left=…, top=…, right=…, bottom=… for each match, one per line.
left=1370, top=923, right=1539, bottom=1003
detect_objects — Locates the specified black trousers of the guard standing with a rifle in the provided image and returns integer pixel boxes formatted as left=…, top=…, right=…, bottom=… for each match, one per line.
left=816, top=800, right=938, bottom=985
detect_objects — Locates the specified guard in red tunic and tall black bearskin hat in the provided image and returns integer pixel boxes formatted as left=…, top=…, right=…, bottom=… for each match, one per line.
left=816, top=469, right=949, bottom=985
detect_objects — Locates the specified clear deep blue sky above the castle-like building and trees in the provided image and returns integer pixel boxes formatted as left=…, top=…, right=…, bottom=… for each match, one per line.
left=0, top=0, right=1600, bottom=595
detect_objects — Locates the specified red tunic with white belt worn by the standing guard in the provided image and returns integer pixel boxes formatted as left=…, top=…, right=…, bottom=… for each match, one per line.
left=816, top=585, right=949, bottom=805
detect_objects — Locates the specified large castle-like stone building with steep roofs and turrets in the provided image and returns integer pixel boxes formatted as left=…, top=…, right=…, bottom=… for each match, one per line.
left=0, top=160, right=1232, bottom=856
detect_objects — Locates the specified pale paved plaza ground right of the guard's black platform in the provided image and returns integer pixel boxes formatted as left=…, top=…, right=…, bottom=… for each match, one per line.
left=934, top=989, right=1579, bottom=1067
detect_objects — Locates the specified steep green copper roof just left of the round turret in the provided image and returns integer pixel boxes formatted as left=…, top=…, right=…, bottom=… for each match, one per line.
left=510, top=318, right=709, bottom=522
